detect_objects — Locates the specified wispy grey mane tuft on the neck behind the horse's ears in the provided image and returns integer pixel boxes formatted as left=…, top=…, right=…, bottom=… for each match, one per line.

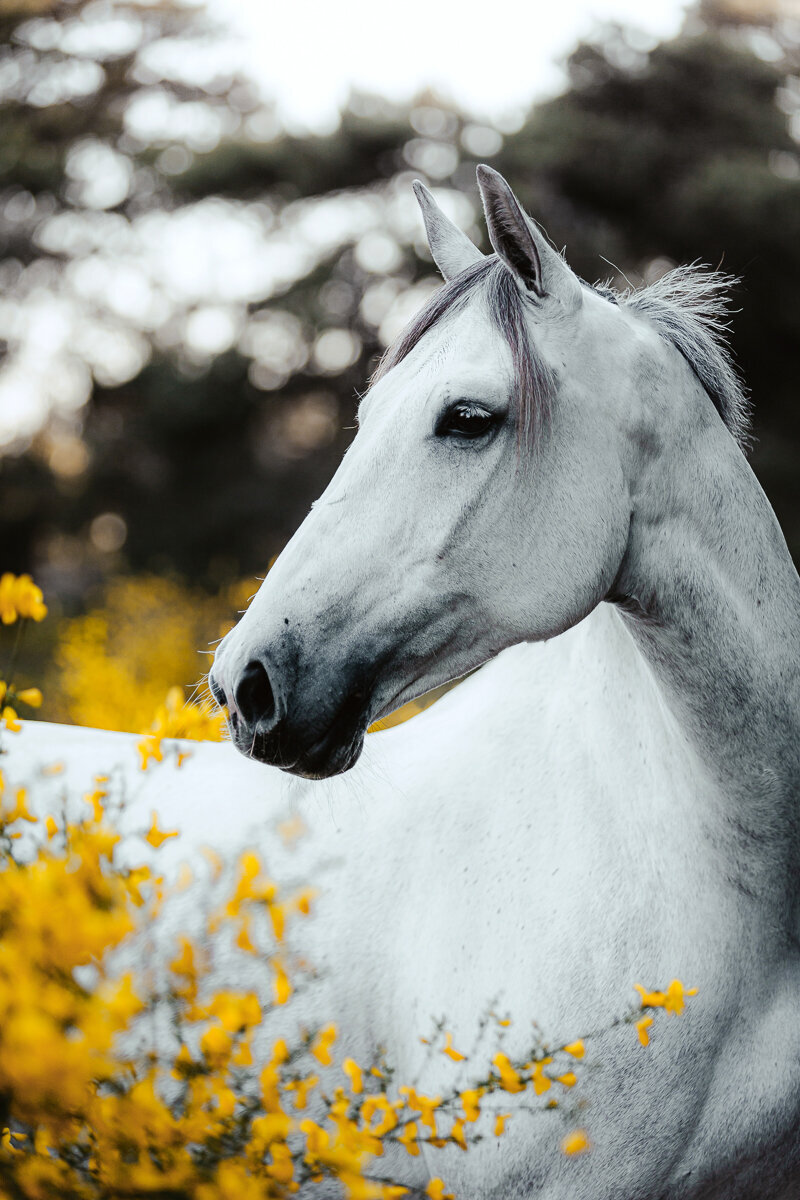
left=619, top=264, right=750, bottom=450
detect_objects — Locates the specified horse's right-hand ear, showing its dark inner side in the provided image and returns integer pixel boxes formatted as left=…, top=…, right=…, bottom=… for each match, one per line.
left=477, top=163, right=581, bottom=302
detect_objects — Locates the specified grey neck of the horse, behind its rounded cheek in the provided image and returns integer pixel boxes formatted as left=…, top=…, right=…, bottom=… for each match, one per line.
left=616, top=408, right=800, bottom=854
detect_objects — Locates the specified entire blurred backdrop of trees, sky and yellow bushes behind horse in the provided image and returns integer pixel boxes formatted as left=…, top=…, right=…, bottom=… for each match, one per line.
left=0, top=0, right=800, bottom=730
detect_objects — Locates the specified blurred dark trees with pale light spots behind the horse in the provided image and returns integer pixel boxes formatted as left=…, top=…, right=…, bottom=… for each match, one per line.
left=0, top=0, right=800, bottom=602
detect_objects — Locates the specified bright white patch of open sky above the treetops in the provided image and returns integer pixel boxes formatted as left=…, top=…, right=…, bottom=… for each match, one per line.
left=210, top=0, right=685, bottom=131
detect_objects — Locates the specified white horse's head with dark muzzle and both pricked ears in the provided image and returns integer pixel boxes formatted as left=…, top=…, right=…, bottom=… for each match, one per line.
left=210, top=167, right=667, bottom=779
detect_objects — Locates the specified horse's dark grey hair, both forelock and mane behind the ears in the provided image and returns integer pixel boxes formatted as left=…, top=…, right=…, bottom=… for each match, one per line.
left=372, top=254, right=750, bottom=450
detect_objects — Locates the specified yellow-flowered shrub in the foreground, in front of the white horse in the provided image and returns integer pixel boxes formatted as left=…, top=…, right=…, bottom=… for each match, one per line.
left=0, top=576, right=693, bottom=1200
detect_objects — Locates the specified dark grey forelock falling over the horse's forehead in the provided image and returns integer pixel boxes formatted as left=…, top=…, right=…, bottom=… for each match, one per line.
left=372, top=254, right=555, bottom=449
